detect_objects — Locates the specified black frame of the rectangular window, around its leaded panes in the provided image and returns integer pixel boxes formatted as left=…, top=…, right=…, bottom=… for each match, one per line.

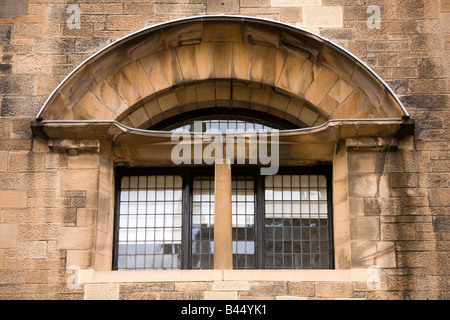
left=112, top=164, right=335, bottom=270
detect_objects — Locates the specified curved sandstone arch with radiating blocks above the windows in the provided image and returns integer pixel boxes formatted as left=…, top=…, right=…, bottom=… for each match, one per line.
left=37, top=16, right=408, bottom=129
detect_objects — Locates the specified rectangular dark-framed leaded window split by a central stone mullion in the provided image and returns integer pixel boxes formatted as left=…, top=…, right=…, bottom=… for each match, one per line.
left=114, top=166, right=333, bottom=270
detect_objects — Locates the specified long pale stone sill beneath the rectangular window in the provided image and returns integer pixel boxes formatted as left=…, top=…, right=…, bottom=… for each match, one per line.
left=79, top=269, right=370, bottom=284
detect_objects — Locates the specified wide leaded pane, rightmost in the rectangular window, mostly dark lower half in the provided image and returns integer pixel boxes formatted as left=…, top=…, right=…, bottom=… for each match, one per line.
left=264, top=175, right=331, bottom=269
